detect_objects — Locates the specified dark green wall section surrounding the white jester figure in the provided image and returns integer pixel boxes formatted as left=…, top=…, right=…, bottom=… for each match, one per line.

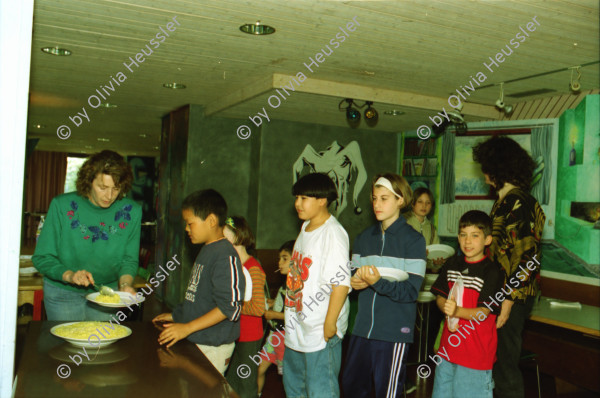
left=251, top=120, right=398, bottom=249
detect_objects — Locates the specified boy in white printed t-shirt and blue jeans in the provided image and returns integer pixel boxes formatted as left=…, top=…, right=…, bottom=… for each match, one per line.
left=283, top=173, right=350, bottom=398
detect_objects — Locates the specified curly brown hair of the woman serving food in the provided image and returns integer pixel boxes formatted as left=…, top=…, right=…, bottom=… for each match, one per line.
left=75, top=150, right=133, bottom=200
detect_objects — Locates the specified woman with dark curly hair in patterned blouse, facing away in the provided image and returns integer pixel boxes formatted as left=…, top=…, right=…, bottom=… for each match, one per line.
left=473, top=136, right=546, bottom=398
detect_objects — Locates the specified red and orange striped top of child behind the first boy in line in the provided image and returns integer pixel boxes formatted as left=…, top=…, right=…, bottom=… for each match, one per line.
left=238, top=257, right=266, bottom=342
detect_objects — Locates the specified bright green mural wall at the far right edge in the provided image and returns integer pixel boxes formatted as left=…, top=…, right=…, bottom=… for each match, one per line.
left=556, top=94, right=600, bottom=264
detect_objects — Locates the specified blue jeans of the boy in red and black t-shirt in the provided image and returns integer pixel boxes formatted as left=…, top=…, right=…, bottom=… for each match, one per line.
left=432, top=359, right=494, bottom=398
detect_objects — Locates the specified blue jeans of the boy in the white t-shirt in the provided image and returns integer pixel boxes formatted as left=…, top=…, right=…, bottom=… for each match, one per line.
left=283, top=335, right=342, bottom=398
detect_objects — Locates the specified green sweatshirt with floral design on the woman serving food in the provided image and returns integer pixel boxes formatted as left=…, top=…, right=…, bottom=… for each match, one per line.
left=32, top=192, right=142, bottom=292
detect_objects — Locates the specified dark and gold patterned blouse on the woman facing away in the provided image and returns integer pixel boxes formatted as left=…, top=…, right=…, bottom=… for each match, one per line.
left=490, top=188, right=546, bottom=302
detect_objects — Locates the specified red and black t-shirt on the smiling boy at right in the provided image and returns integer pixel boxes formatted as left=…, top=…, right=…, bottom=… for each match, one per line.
left=431, top=256, right=506, bottom=370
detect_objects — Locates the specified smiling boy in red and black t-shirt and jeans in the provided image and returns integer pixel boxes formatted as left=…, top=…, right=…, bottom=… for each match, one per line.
left=431, top=210, right=504, bottom=398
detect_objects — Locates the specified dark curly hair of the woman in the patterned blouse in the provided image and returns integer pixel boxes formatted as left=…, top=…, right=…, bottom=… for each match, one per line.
left=473, top=135, right=535, bottom=191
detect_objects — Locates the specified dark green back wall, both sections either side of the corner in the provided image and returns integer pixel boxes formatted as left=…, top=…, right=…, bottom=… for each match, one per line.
left=159, top=105, right=398, bottom=306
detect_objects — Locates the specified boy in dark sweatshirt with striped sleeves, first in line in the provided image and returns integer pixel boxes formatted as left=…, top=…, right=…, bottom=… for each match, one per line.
left=152, top=189, right=246, bottom=374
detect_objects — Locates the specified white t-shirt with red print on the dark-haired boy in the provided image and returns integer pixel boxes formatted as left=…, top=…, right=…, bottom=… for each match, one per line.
left=285, top=216, right=350, bottom=352
